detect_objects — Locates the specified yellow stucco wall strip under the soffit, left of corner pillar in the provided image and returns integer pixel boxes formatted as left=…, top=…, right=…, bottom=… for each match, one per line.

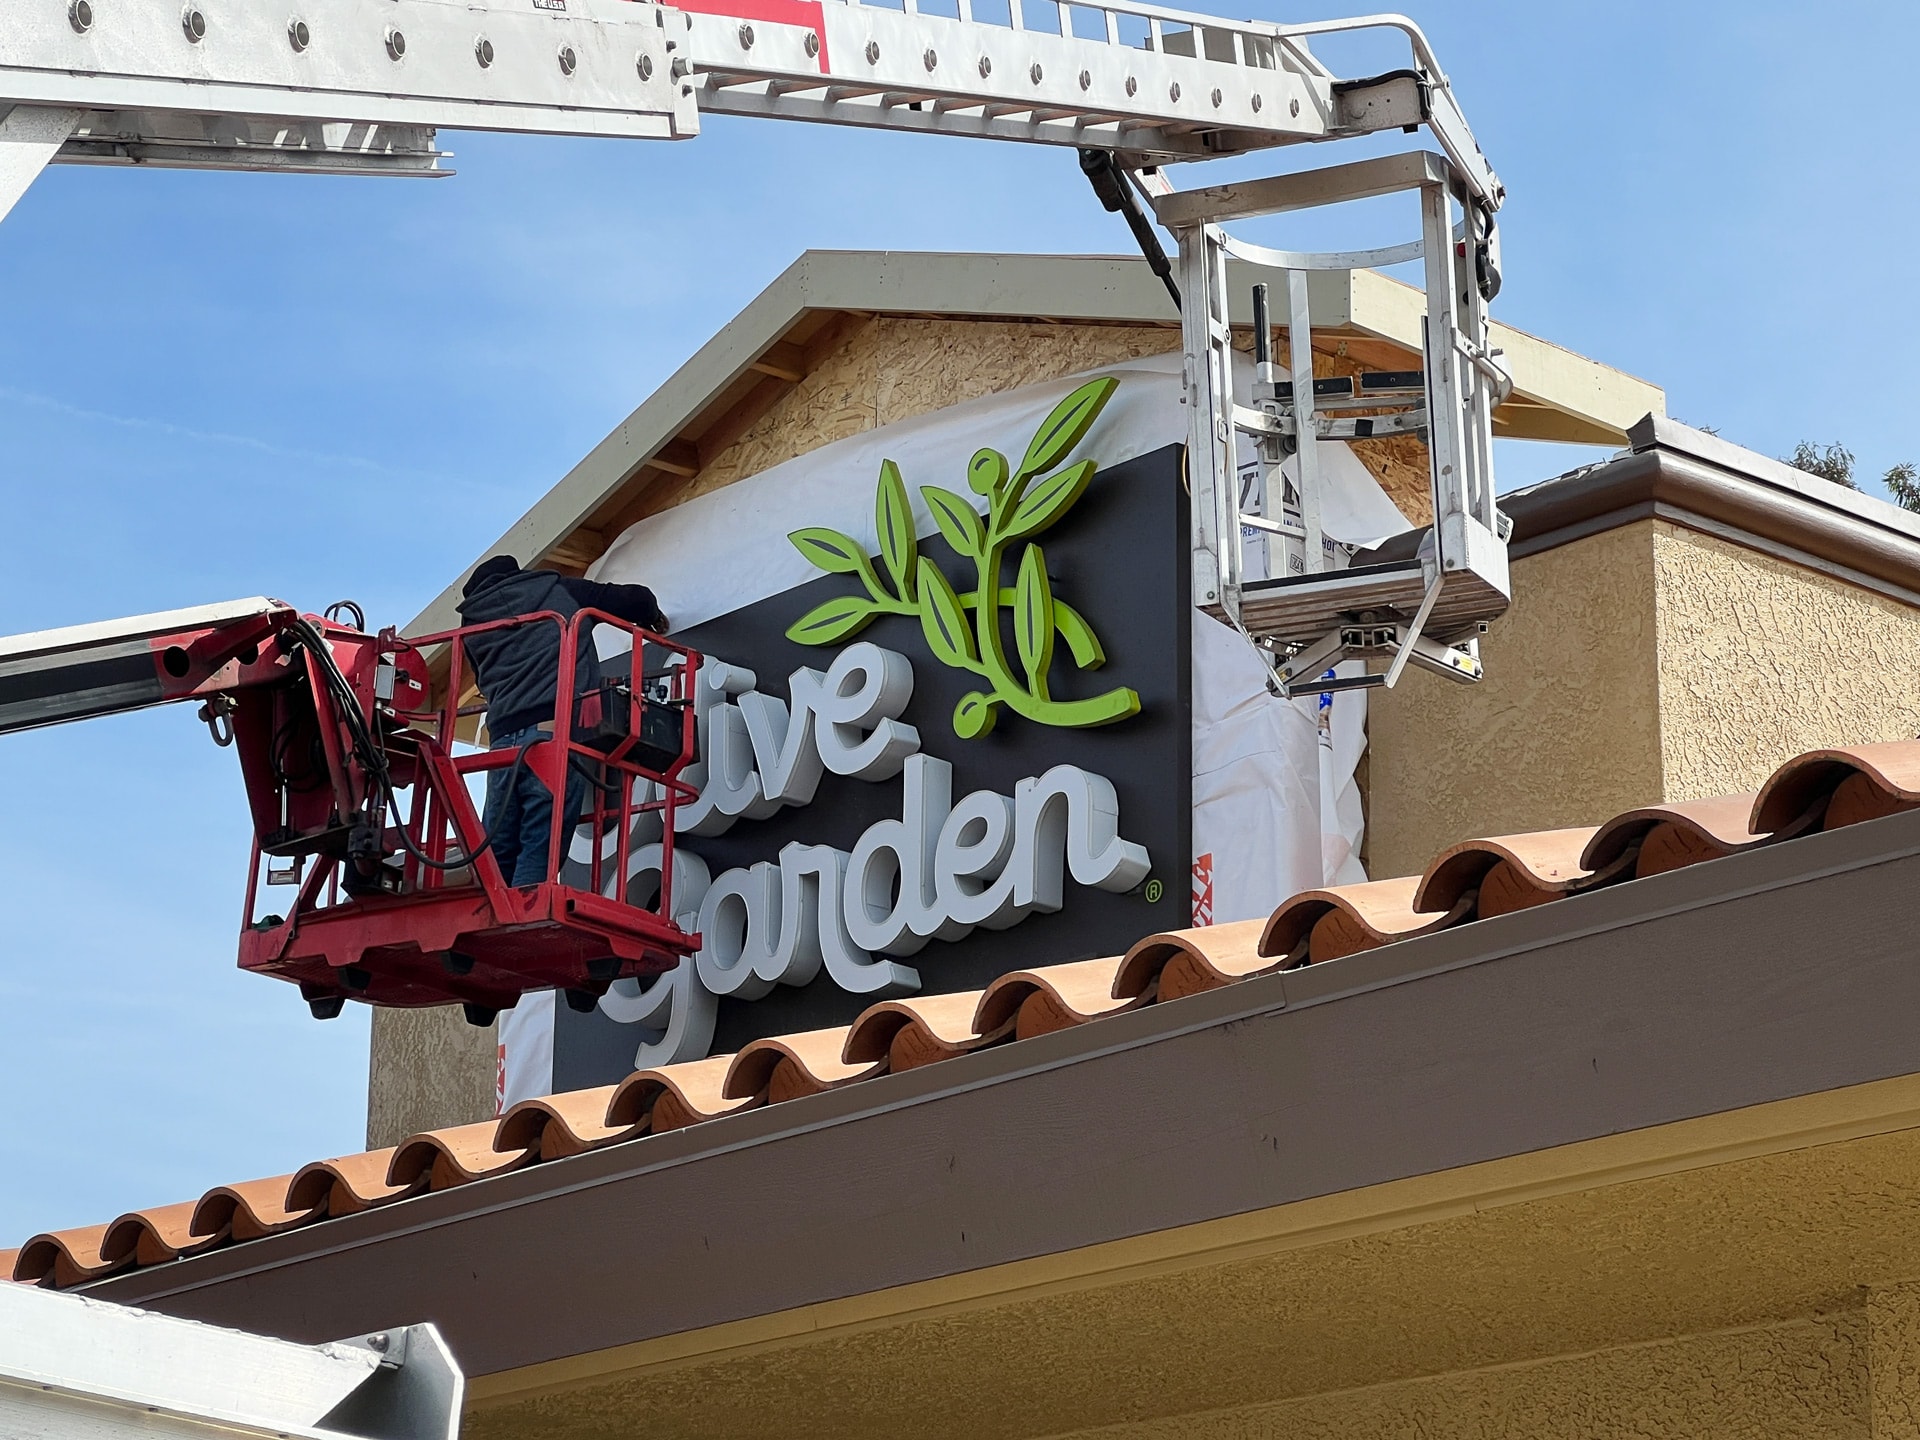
left=1062, top=1309, right=1880, bottom=1440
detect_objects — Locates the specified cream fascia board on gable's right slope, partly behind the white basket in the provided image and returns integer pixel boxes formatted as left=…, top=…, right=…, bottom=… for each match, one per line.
left=1354, top=271, right=1667, bottom=445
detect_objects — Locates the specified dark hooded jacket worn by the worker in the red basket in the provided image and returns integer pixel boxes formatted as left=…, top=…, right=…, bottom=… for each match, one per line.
left=459, top=570, right=666, bottom=735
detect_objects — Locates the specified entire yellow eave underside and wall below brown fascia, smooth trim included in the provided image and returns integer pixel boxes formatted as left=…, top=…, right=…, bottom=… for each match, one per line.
left=465, top=1077, right=1920, bottom=1440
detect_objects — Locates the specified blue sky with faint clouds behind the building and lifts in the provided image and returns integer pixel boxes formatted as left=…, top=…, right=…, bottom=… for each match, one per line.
left=0, top=0, right=1920, bottom=1246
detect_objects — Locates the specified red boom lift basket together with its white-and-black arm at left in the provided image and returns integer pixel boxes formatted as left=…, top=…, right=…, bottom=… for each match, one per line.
left=0, top=597, right=699, bottom=1025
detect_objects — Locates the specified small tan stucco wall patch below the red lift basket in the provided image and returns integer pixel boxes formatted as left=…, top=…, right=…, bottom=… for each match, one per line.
left=367, top=1006, right=497, bottom=1150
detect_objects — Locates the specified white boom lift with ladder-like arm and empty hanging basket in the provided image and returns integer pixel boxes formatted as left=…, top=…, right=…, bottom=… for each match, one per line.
left=0, top=0, right=1511, bottom=693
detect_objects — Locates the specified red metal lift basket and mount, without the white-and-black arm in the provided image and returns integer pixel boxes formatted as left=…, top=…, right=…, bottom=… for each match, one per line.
left=217, top=611, right=699, bottom=1014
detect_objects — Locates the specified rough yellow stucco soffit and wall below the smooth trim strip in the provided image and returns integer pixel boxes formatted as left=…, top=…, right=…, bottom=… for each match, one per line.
left=467, top=1129, right=1920, bottom=1440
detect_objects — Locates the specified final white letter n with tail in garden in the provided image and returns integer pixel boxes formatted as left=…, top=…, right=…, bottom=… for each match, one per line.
left=1006, top=764, right=1152, bottom=912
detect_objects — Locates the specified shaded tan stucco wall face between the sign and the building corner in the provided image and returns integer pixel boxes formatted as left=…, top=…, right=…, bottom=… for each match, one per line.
left=1367, top=520, right=1661, bottom=877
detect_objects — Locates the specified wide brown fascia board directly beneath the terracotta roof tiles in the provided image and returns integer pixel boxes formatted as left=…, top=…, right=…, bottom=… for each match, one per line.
left=88, top=812, right=1920, bottom=1375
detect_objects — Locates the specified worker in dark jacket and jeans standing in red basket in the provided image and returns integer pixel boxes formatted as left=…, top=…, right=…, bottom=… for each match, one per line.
left=459, top=555, right=666, bottom=885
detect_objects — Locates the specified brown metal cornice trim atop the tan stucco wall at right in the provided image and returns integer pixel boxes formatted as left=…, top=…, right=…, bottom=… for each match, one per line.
left=1356, top=415, right=1920, bottom=605
